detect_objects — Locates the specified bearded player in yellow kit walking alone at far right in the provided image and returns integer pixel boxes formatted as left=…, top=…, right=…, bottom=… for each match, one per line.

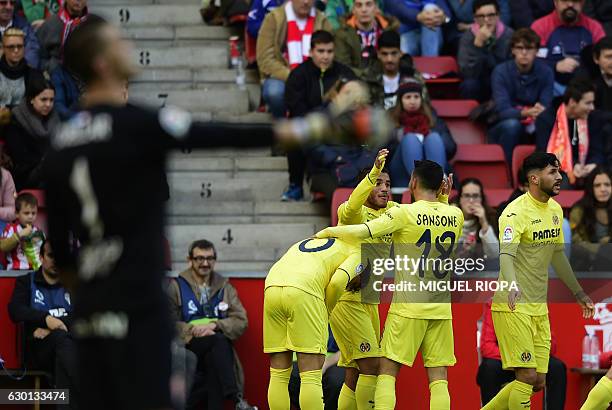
left=483, top=152, right=594, bottom=410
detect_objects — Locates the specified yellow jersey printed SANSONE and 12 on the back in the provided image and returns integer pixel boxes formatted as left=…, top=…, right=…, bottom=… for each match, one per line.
left=366, top=200, right=463, bottom=319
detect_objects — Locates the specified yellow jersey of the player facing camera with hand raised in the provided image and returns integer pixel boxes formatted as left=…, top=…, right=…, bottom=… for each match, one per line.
left=338, top=176, right=398, bottom=302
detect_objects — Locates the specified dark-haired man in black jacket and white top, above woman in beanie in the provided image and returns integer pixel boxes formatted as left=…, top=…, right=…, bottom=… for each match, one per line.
left=364, top=31, right=429, bottom=110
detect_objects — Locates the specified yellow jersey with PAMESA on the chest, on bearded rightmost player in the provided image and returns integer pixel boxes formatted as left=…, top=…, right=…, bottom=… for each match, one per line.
left=491, top=192, right=563, bottom=316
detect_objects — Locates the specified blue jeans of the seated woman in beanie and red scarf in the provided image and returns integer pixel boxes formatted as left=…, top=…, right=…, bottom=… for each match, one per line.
left=389, top=132, right=446, bottom=187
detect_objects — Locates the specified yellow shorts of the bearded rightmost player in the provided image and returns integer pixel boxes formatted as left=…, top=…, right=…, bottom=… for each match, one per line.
left=491, top=311, right=550, bottom=373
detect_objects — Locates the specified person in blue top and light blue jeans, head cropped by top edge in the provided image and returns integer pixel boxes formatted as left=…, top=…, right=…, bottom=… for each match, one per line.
left=385, top=0, right=451, bottom=57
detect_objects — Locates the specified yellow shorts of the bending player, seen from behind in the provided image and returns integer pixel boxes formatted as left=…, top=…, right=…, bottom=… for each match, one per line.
left=263, top=286, right=328, bottom=354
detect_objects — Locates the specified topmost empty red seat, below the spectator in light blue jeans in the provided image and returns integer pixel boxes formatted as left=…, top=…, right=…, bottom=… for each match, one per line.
left=413, top=56, right=460, bottom=98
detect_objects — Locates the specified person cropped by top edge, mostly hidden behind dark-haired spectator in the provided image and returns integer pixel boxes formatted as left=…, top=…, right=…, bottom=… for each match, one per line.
left=445, top=0, right=511, bottom=55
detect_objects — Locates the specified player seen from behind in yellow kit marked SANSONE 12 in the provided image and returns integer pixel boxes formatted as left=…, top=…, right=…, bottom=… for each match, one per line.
left=316, top=160, right=463, bottom=410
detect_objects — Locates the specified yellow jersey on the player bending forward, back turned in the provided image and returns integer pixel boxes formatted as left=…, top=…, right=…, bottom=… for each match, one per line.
left=265, top=238, right=362, bottom=300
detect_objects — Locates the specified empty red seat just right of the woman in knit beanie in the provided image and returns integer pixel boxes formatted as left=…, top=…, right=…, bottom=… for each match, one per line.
left=431, top=100, right=486, bottom=144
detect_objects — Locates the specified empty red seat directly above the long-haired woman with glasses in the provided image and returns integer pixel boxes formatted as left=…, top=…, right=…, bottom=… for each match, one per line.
left=453, top=144, right=511, bottom=188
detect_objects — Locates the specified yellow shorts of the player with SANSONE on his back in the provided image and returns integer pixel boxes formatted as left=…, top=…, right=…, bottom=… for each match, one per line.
left=381, top=313, right=457, bottom=367
